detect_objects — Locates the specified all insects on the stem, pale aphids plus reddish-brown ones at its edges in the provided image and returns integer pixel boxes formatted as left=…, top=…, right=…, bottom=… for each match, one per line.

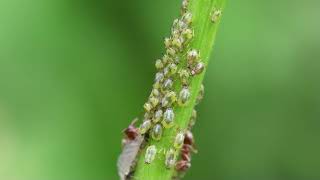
left=119, top=0, right=221, bottom=177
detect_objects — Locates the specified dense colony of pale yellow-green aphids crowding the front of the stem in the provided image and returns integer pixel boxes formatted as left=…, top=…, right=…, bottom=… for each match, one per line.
left=140, top=0, right=205, bottom=170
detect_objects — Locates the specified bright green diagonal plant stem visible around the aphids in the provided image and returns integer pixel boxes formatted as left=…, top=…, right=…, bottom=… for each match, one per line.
left=134, top=0, right=225, bottom=180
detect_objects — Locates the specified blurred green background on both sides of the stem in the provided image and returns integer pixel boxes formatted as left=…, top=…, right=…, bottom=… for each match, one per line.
left=0, top=0, right=320, bottom=180
